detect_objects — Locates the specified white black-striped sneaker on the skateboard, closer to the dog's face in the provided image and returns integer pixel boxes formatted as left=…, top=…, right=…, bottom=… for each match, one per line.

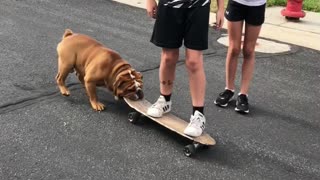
left=147, top=95, right=171, bottom=117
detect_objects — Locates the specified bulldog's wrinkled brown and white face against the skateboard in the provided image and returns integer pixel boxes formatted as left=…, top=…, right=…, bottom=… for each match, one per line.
left=113, top=69, right=144, bottom=100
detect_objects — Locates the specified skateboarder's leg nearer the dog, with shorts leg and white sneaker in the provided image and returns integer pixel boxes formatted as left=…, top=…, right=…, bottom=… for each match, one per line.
left=147, top=5, right=186, bottom=117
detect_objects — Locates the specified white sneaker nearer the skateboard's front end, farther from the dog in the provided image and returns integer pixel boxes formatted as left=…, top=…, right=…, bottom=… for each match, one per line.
left=184, top=111, right=206, bottom=137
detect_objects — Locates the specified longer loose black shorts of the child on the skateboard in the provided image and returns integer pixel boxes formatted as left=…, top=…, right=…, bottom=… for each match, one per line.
left=151, top=5, right=210, bottom=50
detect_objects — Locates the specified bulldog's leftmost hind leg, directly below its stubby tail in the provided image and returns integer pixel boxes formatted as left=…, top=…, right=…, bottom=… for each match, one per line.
left=56, top=57, right=73, bottom=96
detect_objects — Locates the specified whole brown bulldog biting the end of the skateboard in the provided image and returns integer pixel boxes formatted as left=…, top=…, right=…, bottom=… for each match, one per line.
left=56, top=29, right=143, bottom=111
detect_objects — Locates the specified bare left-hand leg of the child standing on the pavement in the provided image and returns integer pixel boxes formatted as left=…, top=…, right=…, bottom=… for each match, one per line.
left=226, top=21, right=243, bottom=90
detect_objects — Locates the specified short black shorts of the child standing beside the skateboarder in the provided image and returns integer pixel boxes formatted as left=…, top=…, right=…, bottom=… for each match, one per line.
left=224, top=0, right=266, bottom=26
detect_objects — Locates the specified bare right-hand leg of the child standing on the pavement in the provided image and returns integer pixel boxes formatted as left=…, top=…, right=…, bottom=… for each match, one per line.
left=240, top=23, right=261, bottom=94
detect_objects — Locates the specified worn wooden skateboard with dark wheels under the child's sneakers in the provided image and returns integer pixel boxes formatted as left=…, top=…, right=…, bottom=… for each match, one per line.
left=124, top=98, right=216, bottom=157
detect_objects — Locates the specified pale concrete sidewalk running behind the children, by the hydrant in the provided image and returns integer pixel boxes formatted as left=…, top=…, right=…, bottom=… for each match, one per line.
left=113, top=0, right=320, bottom=51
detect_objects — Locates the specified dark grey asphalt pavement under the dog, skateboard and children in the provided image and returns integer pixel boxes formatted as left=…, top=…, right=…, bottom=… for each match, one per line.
left=0, top=0, right=320, bottom=180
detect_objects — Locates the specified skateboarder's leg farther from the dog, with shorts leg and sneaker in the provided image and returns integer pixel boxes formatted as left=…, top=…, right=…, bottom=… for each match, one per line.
left=184, top=6, right=210, bottom=136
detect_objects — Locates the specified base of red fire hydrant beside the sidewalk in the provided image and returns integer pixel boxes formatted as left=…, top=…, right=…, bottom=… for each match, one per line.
left=281, top=0, right=306, bottom=19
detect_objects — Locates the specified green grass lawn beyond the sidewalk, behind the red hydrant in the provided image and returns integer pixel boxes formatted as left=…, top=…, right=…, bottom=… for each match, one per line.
left=211, top=0, right=320, bottom=12
